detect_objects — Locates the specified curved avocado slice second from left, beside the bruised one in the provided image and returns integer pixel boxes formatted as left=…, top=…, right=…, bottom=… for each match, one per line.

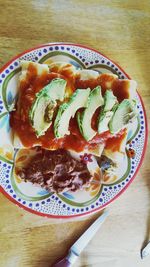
left=54, top=88, right=90, bottom=138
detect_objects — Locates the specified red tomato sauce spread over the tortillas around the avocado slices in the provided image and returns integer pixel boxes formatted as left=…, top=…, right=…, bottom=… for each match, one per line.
left=10, top=64, right=124, bottom=152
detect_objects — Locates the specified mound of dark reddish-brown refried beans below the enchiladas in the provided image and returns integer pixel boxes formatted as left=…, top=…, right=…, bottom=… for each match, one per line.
left=16, top=149, right=92, bottom=193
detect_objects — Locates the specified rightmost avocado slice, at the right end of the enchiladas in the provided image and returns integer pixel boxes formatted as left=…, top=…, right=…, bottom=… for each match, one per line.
left=109, top=99, right=138, bottom=134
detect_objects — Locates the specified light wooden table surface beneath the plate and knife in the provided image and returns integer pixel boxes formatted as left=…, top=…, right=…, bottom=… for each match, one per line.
left=0, top=0, right=150, bottom=267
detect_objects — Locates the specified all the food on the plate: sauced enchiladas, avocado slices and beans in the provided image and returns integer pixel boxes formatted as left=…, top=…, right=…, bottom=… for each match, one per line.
left=10, top=61, right=138, bottom=192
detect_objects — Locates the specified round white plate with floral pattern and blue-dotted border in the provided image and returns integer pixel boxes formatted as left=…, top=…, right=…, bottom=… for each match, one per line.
left=0, top=43, right=147, bottom=218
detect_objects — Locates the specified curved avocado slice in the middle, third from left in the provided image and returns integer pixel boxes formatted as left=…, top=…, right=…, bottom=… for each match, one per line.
left=77, top=86, right=104, bottom=141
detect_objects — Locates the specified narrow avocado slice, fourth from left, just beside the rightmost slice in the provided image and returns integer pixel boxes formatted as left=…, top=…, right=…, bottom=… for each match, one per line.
left=98, top=90, right=118, bottom=134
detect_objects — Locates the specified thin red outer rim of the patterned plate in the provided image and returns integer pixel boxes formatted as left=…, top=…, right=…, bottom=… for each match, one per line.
left=0, top=42, right=148, bottom=219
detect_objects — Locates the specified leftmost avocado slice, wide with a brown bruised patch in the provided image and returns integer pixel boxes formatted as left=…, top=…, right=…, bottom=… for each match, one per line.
left=29, top=78, right=67, bottom=137
